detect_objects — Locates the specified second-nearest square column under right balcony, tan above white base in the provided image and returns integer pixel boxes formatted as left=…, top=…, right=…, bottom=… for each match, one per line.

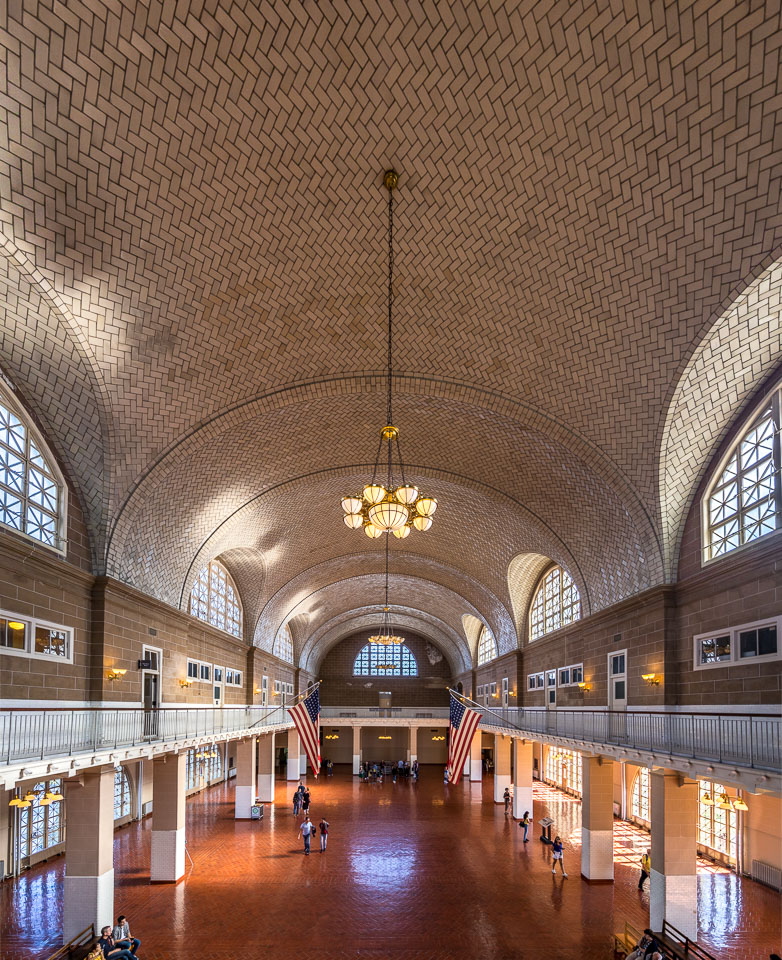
left=581, top=755, right=614, bottom=881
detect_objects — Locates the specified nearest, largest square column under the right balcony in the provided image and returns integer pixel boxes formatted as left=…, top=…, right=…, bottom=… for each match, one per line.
left=649, top=770, right=698, bottom=940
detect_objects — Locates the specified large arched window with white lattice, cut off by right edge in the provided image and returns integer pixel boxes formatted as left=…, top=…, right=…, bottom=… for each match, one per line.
left=704, top=388, right=782, bottom=560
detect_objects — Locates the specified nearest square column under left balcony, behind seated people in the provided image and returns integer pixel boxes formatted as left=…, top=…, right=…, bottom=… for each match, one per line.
left=62, top=767, right=114, bottom=943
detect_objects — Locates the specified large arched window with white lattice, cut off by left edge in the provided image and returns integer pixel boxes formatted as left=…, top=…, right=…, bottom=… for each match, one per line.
left=0, top=380, right=65, bottom=551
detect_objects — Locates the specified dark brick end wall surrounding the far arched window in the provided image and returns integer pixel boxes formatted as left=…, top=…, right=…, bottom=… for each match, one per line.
left=320, top=630, right=451, bottom=707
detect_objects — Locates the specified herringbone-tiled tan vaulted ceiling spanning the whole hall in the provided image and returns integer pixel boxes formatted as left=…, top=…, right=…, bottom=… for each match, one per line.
left=0, top=0, right=782, bottom=660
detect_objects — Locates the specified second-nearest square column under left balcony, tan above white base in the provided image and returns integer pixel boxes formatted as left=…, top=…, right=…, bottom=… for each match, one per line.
left=149, top=753, right=187, bottom=883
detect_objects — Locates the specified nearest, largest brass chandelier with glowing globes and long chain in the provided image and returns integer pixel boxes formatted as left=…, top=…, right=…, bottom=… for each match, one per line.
left=342, top=170, right=437, bottom=540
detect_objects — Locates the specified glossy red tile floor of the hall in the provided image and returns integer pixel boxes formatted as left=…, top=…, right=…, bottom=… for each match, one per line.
left=0, top=768, right=782, bottom=960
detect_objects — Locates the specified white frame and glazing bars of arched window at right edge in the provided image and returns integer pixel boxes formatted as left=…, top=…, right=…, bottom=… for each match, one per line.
left=700, top=383, right=782, bottom=567
